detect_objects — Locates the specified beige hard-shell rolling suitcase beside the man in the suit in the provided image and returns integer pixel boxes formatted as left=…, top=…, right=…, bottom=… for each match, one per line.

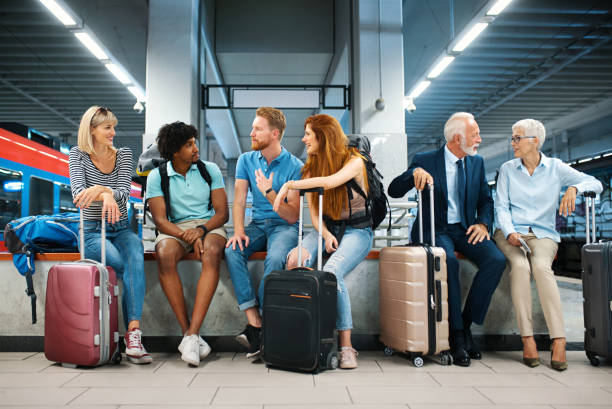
left=379, top=185, right=451, bottom=367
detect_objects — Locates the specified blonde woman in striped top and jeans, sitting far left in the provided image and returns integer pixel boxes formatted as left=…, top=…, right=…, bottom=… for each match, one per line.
left=69, top=106, right=152, bottom=364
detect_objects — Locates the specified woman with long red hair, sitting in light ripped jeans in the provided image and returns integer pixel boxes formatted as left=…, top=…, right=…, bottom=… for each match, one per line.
left=274, top=114, right=373, bottom=369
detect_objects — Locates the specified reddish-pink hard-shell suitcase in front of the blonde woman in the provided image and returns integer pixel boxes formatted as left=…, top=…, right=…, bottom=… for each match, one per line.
left=45, top=213, right=121, bottom=367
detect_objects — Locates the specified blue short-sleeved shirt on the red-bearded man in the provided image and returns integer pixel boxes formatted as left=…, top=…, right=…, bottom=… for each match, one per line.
left=236, top=148, right=304, bottom=220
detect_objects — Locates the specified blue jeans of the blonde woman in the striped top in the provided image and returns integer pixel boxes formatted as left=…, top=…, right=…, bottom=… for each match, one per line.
left=79, top=219, right=145, bottom=328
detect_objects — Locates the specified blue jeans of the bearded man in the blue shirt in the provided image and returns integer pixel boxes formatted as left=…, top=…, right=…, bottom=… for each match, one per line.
left=225, top=219, right=298, bottom=311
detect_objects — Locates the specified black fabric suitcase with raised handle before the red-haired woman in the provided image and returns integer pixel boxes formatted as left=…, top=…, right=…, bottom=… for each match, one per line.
left=261, top=188, right=338, bottom=372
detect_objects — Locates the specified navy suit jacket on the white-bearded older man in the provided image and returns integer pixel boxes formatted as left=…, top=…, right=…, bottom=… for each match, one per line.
left=388, top=147, right=493, bottom=243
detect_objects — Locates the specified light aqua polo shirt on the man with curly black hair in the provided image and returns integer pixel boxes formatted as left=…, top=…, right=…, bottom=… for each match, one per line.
left=146, top=161, right=225, bottom=223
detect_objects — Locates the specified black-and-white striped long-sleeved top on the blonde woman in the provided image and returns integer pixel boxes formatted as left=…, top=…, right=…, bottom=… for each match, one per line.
left=68, top=146, right=132, bottom=220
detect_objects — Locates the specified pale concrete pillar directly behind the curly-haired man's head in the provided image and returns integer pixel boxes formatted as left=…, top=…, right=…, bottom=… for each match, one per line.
left=142, top=0, right=204, bottom=147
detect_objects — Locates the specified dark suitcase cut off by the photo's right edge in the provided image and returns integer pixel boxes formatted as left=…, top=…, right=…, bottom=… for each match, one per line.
left=582, top=192, right=612, bottom=366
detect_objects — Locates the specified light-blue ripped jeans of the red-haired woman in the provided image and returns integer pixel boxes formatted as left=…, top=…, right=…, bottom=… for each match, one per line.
left=302, top=226, right=374, bottom=330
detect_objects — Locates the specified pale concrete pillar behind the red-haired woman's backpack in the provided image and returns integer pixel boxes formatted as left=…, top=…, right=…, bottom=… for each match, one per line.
left=352, top=0, right=408, bottom=191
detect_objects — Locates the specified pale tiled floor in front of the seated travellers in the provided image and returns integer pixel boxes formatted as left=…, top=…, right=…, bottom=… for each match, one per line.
left=0, top=352, right=612, bottom=409
